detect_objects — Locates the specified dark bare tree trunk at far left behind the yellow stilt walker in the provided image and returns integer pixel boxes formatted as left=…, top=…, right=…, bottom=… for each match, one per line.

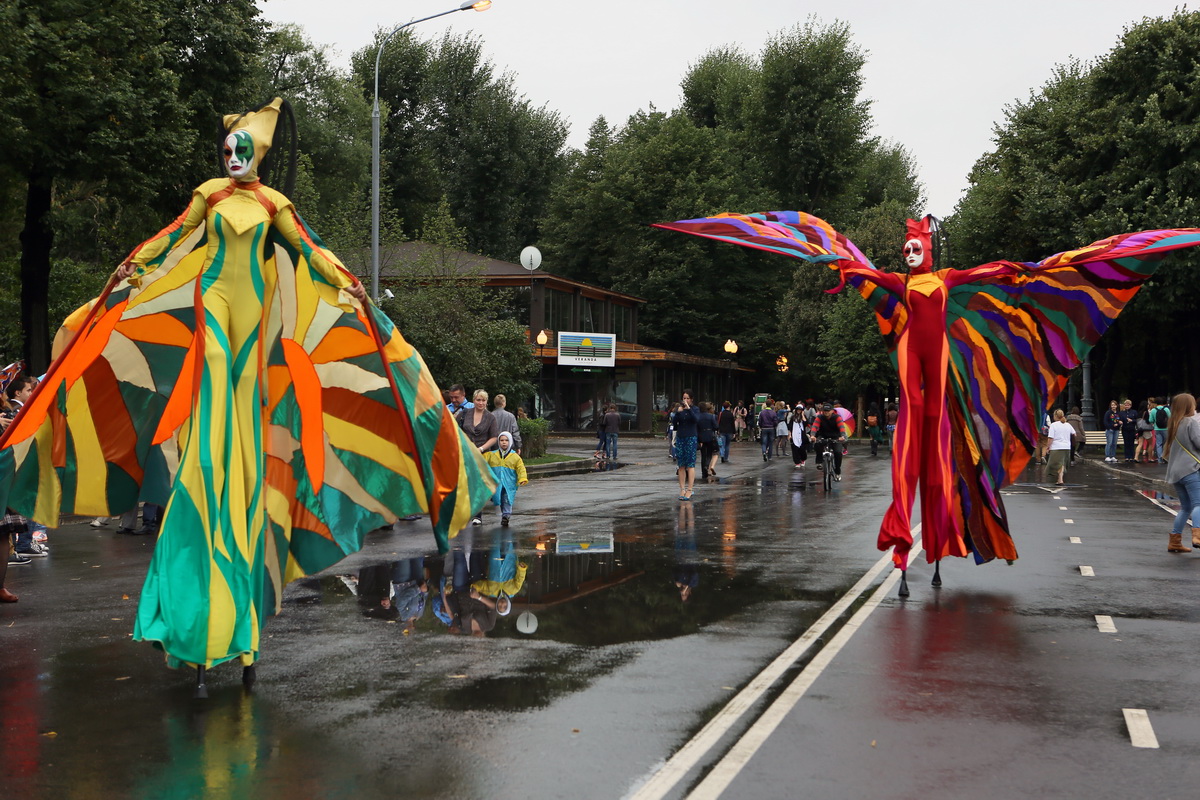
left=20, top=169, right=54, bottom=375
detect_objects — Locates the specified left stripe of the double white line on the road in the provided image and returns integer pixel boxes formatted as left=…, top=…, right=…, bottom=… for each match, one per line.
left=626, top=523, right=922, bottom=800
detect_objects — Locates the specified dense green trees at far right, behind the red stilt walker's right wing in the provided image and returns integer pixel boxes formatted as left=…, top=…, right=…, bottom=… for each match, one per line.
left=950, top=11, right=1200, bottom=397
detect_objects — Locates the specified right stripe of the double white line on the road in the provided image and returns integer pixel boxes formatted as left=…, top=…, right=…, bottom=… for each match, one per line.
left=688, top=546, right=920, bottom=800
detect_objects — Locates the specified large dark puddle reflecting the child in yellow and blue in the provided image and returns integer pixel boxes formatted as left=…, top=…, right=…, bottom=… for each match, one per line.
left=295, top=504, right=804, bottom=646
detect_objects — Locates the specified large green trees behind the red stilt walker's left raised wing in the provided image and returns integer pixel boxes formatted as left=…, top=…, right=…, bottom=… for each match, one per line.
left=544, top=23, right=923, bottom=392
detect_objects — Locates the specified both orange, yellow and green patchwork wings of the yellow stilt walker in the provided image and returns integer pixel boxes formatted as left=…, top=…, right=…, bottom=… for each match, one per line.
left=0, top=219, right=494, bottom=609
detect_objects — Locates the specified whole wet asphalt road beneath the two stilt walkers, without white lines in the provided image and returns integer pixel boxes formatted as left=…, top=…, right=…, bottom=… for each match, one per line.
left=0, top=439, right=1200, bottom=799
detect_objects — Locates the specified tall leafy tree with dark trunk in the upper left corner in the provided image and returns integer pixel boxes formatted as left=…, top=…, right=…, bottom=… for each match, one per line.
left=0, top=0, right=257, bottom=371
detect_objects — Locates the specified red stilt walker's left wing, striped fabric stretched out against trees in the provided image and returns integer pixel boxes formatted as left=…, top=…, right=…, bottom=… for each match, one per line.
left=652, top=211, right=907, bottom=350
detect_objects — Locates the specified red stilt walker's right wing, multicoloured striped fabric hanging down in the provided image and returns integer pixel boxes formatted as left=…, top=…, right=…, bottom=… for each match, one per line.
left=947, top=229, right=1200, bottom=561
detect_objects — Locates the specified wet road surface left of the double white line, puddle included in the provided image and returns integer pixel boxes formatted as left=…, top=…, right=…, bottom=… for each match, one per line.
left=0, top=448, right=902, bottom=800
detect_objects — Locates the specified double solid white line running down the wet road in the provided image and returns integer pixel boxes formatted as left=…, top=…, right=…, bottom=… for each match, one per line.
left=628, top=523, right=922, bottom=800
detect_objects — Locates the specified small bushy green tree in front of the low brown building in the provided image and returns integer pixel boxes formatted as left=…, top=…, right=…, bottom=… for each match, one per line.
left=383, top=204, right=538, bottom=407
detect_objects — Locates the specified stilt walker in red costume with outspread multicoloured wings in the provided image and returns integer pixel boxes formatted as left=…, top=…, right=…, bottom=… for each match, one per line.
left=655, top=211, right=1200, bottom=596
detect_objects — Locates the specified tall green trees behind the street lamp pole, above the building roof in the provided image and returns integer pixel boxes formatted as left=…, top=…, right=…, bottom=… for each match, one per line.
left=353, top=30, right=566, bottom=259
